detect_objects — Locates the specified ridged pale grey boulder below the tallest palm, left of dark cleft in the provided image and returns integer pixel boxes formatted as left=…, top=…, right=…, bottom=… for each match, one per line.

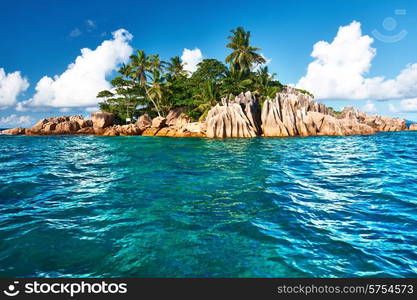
left=206, top=92, right=261, bottom=138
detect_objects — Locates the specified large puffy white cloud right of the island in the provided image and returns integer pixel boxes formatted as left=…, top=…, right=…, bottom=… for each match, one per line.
left=297, top=21, right=417, bottom=100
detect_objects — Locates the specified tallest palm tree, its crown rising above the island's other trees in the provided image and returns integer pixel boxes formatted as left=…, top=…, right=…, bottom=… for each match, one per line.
left=226, top=27, right=266, bottom=75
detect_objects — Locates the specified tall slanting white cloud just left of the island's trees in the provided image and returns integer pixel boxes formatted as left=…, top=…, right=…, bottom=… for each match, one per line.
left=16, top=29, right=133, bottom=110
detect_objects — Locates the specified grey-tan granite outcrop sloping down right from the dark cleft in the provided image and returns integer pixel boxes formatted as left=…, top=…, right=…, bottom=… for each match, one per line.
left=261, top=87, right=406, bottom=137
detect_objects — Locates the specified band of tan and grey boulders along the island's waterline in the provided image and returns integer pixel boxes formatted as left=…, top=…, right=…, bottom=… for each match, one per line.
left=2, top=87, right=417, bottom=138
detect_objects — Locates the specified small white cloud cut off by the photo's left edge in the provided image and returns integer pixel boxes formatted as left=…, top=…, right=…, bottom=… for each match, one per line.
left=0, top=68, right=29, bottom=109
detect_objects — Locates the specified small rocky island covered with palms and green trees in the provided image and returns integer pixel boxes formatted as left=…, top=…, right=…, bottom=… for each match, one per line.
left=2, top=27, right=417, bottom=138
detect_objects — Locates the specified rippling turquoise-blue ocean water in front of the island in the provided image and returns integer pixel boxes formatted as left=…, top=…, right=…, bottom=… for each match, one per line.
left=0, top=132, right=417, bottom=277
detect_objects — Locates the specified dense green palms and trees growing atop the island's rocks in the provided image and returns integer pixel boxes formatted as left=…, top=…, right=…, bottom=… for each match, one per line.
left=97, top=27, right=300, bottom=123
